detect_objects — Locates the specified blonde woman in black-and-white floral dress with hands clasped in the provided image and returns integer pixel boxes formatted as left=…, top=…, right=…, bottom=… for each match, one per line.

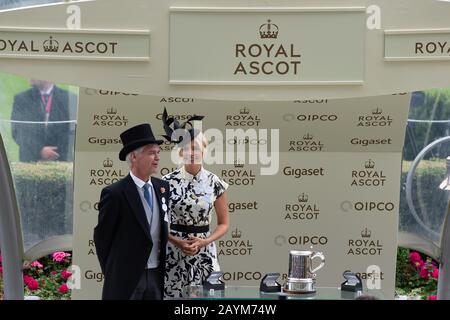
left=163, top=112, right=229, bottom=298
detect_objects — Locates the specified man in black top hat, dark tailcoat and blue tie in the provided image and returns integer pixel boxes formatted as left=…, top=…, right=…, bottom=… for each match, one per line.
left=94, top=124, right=169, bottom=300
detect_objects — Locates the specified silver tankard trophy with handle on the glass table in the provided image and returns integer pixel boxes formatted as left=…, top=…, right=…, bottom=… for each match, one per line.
left=283, top=250, right=325, bottom=294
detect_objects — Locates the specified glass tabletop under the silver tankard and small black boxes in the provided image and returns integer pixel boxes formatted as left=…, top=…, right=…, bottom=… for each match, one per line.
left=181, top=285, right=387, bottom=300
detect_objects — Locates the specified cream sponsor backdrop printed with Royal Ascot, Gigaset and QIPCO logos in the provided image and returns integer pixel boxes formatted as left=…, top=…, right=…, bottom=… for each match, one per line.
left=73, top=88, right=410, bottom=299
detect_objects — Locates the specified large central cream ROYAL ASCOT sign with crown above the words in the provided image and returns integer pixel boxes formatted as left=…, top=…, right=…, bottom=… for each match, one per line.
left=170, top=7, right=366, bottom=85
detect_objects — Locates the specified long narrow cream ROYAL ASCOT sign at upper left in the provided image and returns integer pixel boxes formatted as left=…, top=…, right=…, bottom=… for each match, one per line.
left=0, top=28, right=150, bottom=61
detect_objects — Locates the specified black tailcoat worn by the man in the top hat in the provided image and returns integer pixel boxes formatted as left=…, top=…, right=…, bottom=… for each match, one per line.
left=94, top=175, right=170, bottom=300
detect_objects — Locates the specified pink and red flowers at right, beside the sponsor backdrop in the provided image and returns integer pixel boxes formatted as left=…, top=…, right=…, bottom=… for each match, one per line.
left=396, top=248, right=439, bottom=300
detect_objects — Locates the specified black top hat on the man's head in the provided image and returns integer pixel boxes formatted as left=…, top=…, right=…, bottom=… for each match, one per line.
left=119, top=123, right=164, bottom=161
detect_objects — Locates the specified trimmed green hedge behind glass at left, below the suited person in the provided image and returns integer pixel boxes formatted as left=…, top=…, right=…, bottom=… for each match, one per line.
left=11, top=162, right=73, bottom=247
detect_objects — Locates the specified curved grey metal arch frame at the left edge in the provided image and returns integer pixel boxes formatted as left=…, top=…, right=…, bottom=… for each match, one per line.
left=0, top=133, right=24, bottom=300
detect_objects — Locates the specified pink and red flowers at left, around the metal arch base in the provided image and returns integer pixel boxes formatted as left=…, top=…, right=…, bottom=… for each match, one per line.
left=0, top=252, right=72, bottom=300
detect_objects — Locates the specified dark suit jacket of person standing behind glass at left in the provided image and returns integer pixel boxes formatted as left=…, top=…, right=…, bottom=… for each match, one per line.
left=11, top=86, right=77, bottom=162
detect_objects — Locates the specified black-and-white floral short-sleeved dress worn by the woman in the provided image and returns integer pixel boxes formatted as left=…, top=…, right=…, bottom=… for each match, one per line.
left=162, top=167, right=228, bottom=298
